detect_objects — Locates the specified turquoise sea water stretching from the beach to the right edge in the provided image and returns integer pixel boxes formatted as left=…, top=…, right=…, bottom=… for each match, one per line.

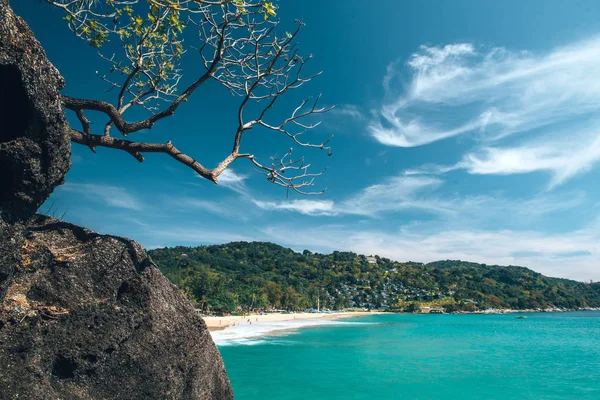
left=219, top=312, right=600, bottom=400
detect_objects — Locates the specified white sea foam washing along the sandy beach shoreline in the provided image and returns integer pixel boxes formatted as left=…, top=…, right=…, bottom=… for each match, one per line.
left=211, top=318, right=359, bottom=346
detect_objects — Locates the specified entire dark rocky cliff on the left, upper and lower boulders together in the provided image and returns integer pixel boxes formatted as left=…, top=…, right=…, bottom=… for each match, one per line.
left=0, top=0, right=233, bottom=399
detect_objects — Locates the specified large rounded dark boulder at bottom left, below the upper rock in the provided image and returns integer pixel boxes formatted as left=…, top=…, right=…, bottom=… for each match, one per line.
left=0, top=216, right=233, bottom=400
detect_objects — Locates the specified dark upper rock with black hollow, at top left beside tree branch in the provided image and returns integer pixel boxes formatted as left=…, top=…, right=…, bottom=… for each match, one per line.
left=0, top=0, right=71, bottom=222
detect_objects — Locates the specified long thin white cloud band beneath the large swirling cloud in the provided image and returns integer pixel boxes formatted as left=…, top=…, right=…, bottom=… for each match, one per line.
left=251, top=176, right=586, bottom=220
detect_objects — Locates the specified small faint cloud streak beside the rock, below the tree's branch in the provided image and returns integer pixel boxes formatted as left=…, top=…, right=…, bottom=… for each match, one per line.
left=59, top=182, right=144, bottom=211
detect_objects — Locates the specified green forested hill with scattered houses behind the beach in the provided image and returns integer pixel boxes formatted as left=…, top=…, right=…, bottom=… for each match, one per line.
left=148, top=242, right=600, bottom=312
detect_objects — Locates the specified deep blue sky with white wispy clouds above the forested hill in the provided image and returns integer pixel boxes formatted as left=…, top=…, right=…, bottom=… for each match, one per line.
left=13, top=0, right=600, bottom=280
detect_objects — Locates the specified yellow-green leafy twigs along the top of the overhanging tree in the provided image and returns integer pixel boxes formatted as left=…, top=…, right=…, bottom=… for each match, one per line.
left=48, top=0, right=282, bottom=107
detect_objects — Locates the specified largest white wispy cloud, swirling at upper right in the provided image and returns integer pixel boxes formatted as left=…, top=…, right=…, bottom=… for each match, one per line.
left=368, top=38, right=600, bottom=147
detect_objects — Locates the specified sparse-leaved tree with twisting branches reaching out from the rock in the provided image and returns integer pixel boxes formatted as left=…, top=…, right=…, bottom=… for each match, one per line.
left=45, top=0, right=331, bottom=194
